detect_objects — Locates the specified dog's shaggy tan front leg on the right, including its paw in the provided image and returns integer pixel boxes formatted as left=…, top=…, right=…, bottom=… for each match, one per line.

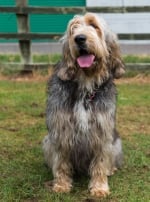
left=89, top=157, right=109, bottom=197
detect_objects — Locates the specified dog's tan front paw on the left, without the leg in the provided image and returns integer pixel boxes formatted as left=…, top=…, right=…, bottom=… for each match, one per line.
left=52, top=183, right=72, bottom=193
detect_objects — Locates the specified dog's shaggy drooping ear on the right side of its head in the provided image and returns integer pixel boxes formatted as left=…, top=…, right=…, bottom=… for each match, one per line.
left=106, top=33, right=125, bottom=79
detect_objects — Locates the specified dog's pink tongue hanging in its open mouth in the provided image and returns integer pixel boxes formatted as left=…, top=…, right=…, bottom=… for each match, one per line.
left=77, top=54, right=95, bottom=68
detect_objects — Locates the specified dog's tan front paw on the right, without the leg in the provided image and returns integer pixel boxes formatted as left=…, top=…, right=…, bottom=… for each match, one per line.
left=90, top=181, right=110, bottom=197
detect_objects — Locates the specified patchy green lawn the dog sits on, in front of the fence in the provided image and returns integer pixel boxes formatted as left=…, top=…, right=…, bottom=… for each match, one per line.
left=0, top=80, right=150, bottom=202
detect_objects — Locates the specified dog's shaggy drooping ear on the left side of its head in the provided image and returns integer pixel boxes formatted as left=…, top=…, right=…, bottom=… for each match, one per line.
left=57, top=36, right=76, bottom=81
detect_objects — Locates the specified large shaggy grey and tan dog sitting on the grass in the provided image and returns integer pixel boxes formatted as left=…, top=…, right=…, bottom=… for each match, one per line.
left=43, top=13, right=125, bottom=197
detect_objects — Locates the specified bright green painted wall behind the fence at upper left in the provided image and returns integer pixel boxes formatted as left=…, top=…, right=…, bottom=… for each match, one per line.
left=0, top=0, right=86, bottom=42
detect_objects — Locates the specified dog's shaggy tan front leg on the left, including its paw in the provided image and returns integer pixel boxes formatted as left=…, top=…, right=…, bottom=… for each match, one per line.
left=52, top=152, right=72, bottom=192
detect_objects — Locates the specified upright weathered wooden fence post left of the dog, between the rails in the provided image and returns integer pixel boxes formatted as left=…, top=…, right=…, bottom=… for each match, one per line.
left=16, top=0, right=32, bottom=64
